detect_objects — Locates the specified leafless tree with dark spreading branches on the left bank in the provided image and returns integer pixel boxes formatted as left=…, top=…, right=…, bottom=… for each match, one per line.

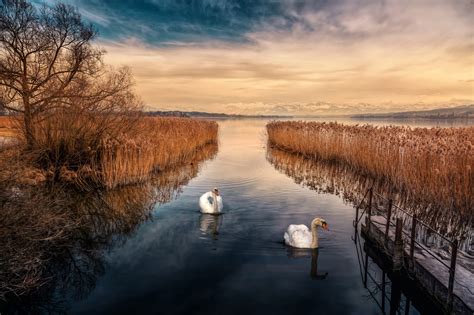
left=0, top=0, right=131, bottom=148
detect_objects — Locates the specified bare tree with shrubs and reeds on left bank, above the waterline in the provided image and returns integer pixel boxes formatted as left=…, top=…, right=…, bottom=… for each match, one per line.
left=0, top=0, right=217, bottom=190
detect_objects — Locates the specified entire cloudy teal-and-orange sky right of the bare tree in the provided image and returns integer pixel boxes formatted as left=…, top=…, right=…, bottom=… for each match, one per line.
left=36, top=0, right=474, bottom=115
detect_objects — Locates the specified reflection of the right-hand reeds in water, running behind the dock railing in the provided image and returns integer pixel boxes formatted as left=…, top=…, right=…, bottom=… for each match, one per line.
left=267, top=147, right=474, bottom=253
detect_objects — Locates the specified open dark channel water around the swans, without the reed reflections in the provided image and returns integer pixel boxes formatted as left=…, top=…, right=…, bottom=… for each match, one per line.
left=56, top=120, right=470, bottom=314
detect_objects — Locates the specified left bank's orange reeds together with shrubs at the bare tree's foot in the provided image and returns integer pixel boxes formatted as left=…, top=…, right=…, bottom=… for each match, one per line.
left=31, top=112, right=218, bottom=189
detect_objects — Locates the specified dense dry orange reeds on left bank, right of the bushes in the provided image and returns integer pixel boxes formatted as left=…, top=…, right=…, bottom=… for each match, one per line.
left=100, top=117, right=218, bottom=188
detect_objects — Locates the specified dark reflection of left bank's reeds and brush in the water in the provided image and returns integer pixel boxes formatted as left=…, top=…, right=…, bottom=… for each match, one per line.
left=0, top=145, right=218, bottom=314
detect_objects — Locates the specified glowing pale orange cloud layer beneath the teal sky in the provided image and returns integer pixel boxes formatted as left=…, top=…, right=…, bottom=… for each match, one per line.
left=101, top=1, right=474, bottom=114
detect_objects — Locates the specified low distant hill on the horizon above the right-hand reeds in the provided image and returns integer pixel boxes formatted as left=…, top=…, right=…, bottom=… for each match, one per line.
left=351, top=104, right=474, bottom=119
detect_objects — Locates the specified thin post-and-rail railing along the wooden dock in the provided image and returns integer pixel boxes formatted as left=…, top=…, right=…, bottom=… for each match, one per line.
left=353, top=187, right=458, bottom=310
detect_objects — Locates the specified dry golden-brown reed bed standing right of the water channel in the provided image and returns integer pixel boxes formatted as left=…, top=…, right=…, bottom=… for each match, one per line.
left=267, top=122, right=474, bottom=235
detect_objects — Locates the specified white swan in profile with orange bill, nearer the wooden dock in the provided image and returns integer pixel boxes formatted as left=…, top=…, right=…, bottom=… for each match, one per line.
left=284, top=218, right=328, bottom=248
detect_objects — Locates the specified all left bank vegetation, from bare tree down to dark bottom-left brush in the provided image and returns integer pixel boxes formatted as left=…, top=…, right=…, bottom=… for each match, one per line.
left=0, top=0, right=218, bottom=304
